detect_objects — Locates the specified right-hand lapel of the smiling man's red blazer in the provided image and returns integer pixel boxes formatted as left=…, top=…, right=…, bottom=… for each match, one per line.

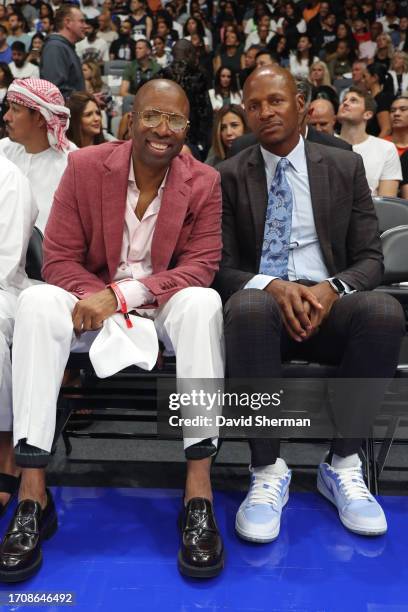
left=151, top=157, right=192, bottom=274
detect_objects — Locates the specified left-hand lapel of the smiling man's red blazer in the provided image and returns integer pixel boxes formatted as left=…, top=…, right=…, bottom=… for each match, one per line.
left=102, top=141, right=132, bottom=279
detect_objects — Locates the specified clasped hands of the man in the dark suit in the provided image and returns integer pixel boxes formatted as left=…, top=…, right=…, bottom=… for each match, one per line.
left=266, top=278, right=339, bottom=342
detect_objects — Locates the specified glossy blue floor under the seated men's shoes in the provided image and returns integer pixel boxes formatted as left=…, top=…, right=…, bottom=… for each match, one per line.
left=0, top=488, right=408, bottom=612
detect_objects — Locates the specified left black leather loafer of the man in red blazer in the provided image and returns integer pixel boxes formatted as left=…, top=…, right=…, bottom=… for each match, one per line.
left=0, top=489, right=58, bottom=582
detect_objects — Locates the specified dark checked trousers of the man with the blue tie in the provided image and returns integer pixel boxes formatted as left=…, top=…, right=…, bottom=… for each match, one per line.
left=224, top=289, right=405, bottom=467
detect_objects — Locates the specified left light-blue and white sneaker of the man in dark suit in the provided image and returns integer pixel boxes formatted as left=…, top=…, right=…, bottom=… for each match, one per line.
left=235, top=458, right=292, bottom=542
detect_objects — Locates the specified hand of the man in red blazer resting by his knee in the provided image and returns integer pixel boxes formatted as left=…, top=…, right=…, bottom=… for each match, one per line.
left=72, top=288, right=118, bottom=334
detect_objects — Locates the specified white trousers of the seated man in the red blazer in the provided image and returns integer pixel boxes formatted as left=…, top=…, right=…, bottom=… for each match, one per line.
left=12, top=284, right=225, bottom=451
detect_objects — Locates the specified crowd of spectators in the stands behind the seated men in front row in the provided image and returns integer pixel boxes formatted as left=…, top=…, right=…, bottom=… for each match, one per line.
left=0, top=0, right=408, bottom=196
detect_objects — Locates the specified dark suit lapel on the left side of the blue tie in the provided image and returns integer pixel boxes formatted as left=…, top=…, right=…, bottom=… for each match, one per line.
left=247, top=146, right=268, bottom=268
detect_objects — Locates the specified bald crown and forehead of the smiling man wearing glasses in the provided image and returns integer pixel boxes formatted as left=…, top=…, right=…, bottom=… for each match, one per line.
left=133, top=79, right=190, bottom=117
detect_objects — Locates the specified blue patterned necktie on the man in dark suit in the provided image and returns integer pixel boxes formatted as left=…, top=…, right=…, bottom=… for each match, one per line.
left=259, top=157, right=293, bottom=280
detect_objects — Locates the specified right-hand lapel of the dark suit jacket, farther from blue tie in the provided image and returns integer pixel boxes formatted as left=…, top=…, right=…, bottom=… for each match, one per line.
left=305, top=140, right=334, bottom=274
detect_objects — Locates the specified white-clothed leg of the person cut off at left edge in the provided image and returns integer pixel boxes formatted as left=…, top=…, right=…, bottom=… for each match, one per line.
left=0, top=291, right=17, bottom=431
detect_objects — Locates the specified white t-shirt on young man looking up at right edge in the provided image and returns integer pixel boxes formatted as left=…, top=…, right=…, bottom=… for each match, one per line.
left=353, top=136, right=402, bottom=195
